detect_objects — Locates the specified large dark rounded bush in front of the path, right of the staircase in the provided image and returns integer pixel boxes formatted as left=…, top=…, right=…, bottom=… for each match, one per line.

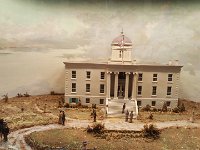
left=142, top=124, right=160, bottom=139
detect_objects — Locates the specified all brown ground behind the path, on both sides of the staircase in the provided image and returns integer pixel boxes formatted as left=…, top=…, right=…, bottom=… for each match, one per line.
left=0, top=95, right=200, bottom=130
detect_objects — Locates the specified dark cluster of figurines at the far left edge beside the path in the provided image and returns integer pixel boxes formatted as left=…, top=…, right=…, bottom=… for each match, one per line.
left=0, top=119, right=10, bottom=142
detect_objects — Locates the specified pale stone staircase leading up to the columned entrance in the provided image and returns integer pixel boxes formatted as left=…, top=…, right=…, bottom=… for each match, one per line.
left=107, top=99, right=137, bottom=117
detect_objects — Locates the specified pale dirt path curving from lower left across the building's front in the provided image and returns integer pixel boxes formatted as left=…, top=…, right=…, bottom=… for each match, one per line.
left=0, top=118, right=200, bottom=150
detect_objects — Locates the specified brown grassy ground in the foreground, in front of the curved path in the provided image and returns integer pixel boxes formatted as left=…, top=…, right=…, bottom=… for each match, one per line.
left=25, top=128, right=200, bottom=150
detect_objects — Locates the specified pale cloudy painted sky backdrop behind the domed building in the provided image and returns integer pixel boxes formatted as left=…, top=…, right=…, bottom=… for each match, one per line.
left=0, top=0, right=200, bottom=101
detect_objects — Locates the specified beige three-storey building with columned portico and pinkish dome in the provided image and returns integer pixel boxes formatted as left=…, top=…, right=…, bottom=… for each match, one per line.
left=64, top=33, right=182, bottom=113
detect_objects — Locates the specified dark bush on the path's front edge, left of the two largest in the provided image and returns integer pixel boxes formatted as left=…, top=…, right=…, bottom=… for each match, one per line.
left=86, top=123, right=104, bottom=134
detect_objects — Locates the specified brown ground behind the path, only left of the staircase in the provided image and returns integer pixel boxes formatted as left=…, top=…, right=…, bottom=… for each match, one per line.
left=0, top=95, right=103, bottom=131
